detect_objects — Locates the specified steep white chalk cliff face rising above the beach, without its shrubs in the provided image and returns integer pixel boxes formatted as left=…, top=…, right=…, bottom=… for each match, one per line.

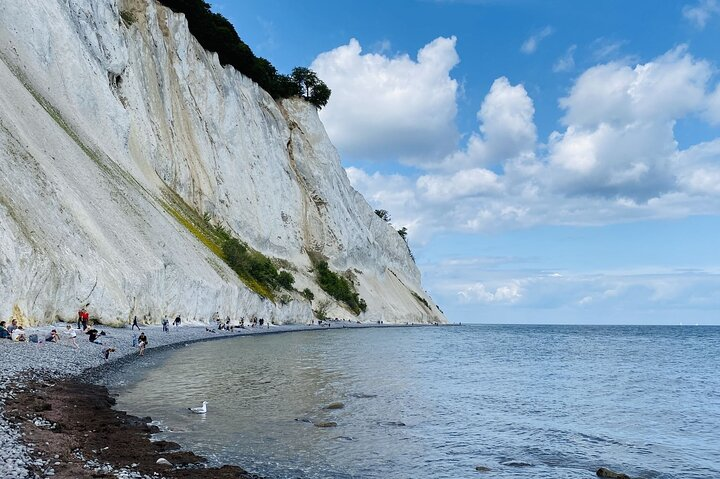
left=0, top=0, right=445, bottom=322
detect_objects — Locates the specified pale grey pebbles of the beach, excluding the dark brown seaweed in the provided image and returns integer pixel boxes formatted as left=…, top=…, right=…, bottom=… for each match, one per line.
left=0, top=321, right=374, bottom=479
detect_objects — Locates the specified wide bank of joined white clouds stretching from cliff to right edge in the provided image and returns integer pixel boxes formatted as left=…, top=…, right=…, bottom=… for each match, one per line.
left=340, top=46, right=720, bottom=237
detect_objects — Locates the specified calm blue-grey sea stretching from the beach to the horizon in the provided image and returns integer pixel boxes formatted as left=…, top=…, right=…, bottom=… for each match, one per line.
left=107, top=325, right=720, bottom=479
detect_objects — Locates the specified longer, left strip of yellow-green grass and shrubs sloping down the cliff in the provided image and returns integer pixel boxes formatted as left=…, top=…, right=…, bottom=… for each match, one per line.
left=162, top=188, right=295, bottom=301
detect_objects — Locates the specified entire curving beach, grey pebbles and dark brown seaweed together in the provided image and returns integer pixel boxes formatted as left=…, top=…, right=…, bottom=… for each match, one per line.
left=0, top=321, right=429, bottom=479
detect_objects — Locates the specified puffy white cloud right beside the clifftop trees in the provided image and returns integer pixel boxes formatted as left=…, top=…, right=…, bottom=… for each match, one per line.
left=310, top=37, right=459, bottom=162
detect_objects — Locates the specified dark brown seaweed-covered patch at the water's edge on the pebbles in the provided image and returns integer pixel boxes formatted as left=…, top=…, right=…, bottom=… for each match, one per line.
left=5, top=378, right=260, bottom=479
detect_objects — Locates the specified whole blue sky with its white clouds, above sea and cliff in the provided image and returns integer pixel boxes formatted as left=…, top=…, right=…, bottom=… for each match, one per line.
left=211, top=0, right=720, bottom=325
